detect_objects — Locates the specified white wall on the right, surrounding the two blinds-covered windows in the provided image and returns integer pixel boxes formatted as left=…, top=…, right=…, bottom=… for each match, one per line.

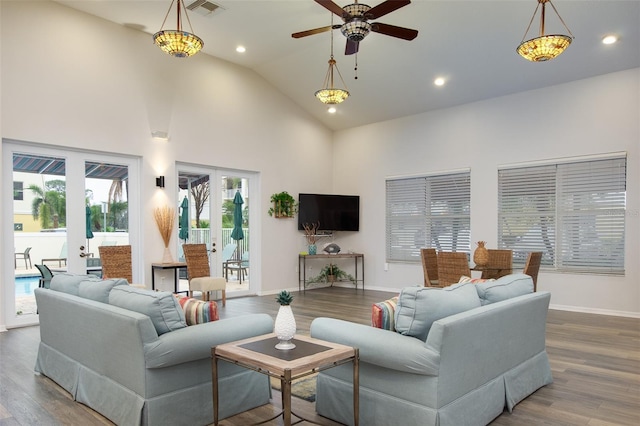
left=333, top=69, right=640, bottom=316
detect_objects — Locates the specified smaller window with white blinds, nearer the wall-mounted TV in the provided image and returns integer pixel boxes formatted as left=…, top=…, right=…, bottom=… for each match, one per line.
left=386, top=171, right=471, bottom=262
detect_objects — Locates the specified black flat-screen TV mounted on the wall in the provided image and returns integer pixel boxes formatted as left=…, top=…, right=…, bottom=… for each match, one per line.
left=298, top=194, right=360, bottom=231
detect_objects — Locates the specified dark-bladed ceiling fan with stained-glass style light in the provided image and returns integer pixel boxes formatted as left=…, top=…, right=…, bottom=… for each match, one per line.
left=291, top=0, right=418, bottom=55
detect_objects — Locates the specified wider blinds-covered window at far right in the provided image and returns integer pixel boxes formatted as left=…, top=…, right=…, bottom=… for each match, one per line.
left=498, top=154, right=626, bottom=275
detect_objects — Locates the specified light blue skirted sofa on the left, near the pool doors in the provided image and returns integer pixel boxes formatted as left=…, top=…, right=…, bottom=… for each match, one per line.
left=35, top=274, right=273, bottom=426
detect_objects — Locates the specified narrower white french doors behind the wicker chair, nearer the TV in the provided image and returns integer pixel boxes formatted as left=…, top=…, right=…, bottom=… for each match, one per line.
left=176, top=164, right=260, bottom=296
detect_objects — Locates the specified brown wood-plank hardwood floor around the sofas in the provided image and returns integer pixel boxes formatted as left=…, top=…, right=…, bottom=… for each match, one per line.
left=0, top=287, right=640, bottom=426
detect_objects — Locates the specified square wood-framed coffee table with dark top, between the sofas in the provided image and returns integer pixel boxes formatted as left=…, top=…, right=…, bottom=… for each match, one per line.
left=211, top=333, right=360, bottom=426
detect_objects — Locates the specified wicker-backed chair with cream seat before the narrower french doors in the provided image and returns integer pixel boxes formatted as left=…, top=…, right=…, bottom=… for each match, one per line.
left=182, top=244, right=227, bottom=306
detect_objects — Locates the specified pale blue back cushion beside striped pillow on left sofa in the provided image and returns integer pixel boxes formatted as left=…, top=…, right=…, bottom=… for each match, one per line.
left=109, top=285, right=187, bottom=335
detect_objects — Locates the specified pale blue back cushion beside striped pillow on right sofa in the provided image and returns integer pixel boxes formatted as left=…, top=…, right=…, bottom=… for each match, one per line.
left=395, top=283, right=481, bottom=341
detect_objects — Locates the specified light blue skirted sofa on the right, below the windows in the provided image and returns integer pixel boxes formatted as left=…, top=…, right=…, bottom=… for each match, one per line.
left=311, top=274, right=552, bottom=426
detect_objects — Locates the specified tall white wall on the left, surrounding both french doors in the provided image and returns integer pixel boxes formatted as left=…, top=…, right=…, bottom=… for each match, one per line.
left=0, top=1, right=332, bottom=327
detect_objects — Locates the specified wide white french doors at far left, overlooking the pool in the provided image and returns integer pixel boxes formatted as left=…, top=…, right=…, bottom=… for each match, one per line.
left=1, top=140, right=141, bottom=327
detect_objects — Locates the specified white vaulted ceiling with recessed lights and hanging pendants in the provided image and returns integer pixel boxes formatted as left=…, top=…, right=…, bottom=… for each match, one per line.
left=56, top=0, right=640, bottom=130
